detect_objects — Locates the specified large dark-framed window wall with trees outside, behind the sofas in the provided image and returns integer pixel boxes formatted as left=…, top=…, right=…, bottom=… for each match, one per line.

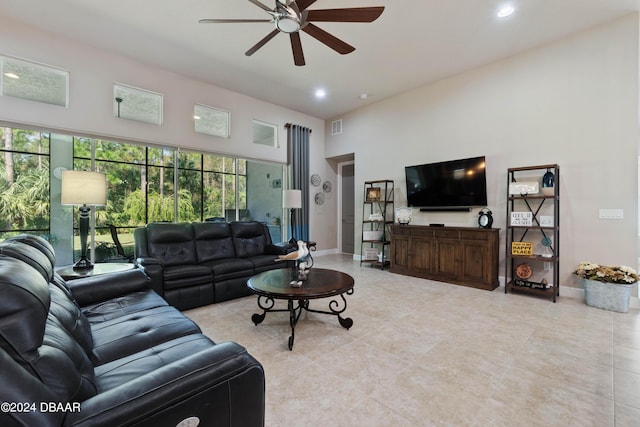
left=0, top=128, right=284, bottom=262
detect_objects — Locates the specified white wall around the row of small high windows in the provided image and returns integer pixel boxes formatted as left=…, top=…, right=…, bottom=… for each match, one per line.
left=0, top=16, right=335, bottom=249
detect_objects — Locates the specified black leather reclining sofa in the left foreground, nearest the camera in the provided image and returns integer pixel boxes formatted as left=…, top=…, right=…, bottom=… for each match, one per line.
left=0, top=235, right=265, bottom=427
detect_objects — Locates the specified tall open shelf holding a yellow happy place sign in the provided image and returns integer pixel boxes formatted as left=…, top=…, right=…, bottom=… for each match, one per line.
left=504, top=164, right=560, bottom=302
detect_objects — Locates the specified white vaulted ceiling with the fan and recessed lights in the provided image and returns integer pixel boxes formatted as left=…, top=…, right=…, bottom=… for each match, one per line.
left=0, top=0, right=640, bottom=119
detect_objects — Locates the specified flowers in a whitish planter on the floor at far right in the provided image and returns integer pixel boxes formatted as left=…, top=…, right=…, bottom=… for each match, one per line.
left=573, top=262, right=639, bottom=313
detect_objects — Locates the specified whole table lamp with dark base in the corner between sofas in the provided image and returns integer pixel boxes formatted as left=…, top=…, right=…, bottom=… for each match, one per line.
left=60, top=170, right=107, bottom=270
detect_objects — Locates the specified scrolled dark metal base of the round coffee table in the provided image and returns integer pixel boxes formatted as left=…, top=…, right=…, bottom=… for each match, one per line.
left=251, top=288, right=353, bottom=350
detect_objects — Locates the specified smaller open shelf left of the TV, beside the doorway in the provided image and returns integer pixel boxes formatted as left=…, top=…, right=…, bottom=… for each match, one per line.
left=360, top=179, right=395, bottom=270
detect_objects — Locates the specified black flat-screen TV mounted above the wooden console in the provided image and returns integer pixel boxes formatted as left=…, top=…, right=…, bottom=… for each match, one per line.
left=405, top=156, right=487, bottom=211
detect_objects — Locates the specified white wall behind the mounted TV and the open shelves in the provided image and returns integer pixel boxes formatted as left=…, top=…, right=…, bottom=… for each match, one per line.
left=325, top=14, right=639, bottom=287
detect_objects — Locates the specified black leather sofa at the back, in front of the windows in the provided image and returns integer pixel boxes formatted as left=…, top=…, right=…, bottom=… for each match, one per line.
left=134, top=221, right=292, bottom=310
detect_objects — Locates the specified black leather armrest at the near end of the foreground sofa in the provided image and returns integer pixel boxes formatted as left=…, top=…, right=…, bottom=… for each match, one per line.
left=65, top=342, right=265, bottom=427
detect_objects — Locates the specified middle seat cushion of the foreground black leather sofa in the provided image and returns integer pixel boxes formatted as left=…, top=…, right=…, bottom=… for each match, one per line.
left=91, top=305, right=201, bottom=365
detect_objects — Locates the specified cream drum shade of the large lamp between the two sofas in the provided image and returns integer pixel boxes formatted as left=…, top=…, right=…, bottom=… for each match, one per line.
left=60, top=170, right=107, bottom=205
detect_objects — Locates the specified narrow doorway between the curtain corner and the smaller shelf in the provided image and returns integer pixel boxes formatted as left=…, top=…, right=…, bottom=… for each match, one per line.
left=338, top=161, right=355, bottom=254
